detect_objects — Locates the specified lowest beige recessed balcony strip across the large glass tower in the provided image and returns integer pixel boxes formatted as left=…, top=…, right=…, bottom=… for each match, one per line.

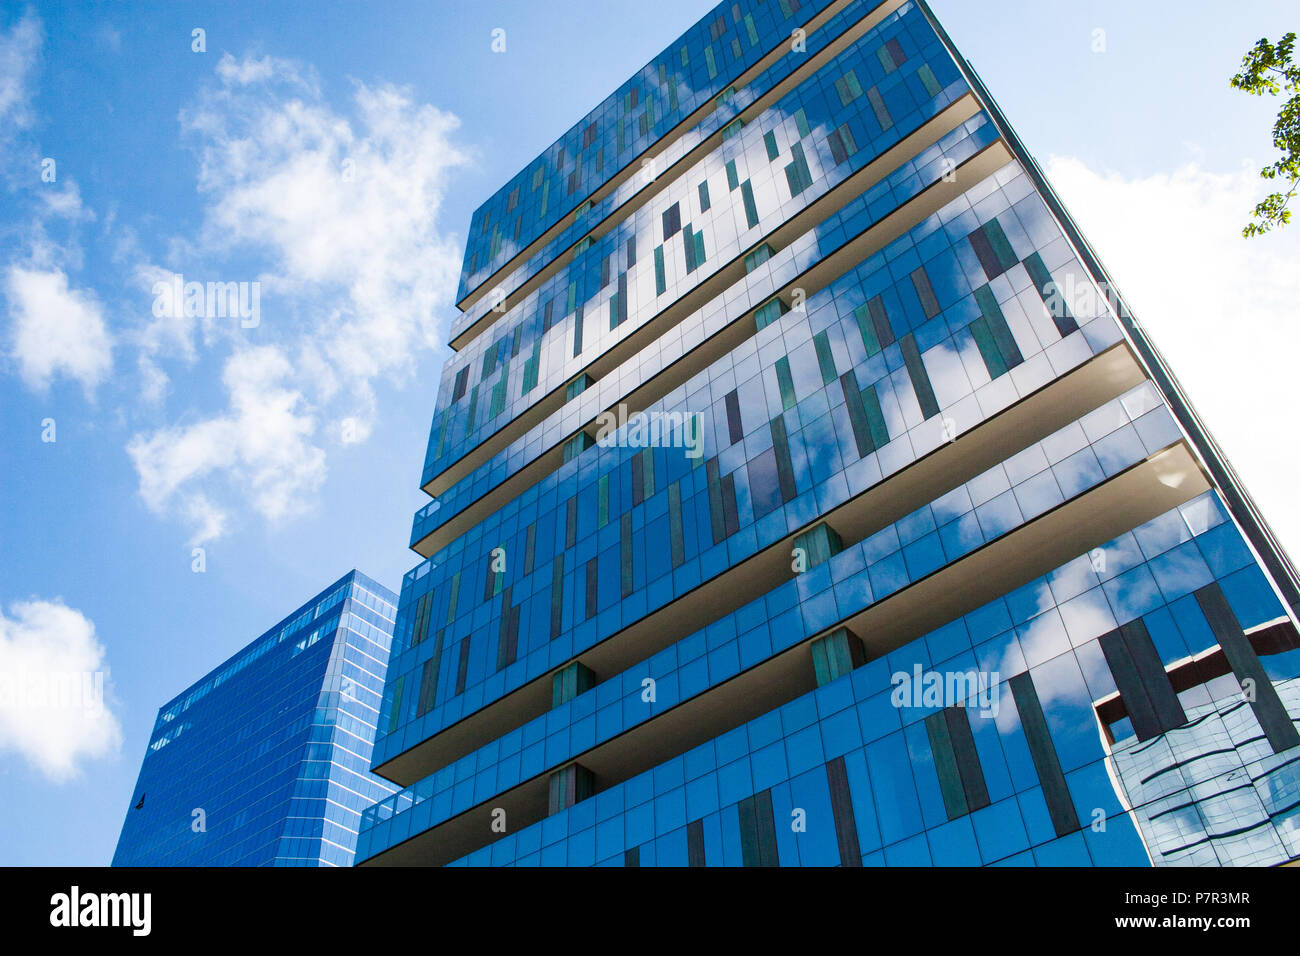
left=358, top=438, right=1212, bottom=866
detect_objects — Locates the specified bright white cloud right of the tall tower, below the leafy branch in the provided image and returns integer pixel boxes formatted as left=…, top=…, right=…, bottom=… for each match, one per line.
left=1047, top=157, right=1300, bottom=557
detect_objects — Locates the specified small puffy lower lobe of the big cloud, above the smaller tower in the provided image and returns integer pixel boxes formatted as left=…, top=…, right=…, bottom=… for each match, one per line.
left=127, top=346, right=325, bottom=544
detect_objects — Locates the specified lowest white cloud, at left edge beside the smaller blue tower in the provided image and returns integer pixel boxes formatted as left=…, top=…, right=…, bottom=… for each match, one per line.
left=0, top=600, right=122, bottom=782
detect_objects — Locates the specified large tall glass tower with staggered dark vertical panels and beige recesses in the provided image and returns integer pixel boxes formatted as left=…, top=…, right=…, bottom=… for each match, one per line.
left=358, top=0, right=1300, bottom=866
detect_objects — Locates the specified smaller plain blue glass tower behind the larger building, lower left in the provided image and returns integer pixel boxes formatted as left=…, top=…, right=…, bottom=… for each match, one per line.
left=113, top=571, right=397, bottom=866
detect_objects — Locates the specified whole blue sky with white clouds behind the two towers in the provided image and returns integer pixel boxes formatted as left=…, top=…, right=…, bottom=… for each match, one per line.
left=0, top=0, right=1300, bottom=865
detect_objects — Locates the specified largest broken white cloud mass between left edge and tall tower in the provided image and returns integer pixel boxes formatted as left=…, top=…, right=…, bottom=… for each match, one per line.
left=129, top=55, right=465, bottom=538
